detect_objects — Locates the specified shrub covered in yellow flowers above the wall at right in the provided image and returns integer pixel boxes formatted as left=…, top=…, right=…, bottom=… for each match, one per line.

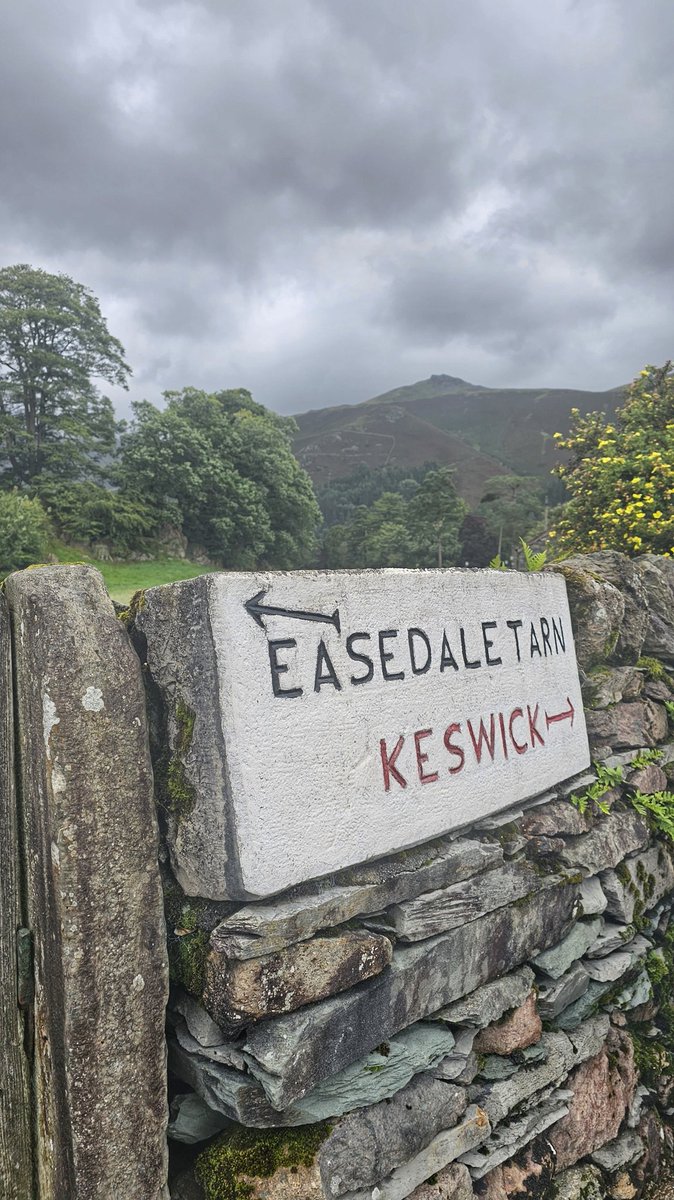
left=550, top=362, right=674, bottom=556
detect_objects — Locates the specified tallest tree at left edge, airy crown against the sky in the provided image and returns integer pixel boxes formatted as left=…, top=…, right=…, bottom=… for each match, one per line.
left=0, top=264, right=130, bottom=486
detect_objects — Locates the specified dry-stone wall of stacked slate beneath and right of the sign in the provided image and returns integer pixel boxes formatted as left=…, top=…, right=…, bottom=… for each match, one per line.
left=154, top=553, right=674, bottom=1200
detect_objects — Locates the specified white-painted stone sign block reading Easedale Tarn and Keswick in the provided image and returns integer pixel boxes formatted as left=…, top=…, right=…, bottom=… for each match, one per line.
left=137, top=570, right=589, bottom=899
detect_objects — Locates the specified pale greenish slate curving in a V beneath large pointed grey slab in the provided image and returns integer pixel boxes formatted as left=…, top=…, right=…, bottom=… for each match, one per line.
left=169, top=1021, right=455, bottom=1128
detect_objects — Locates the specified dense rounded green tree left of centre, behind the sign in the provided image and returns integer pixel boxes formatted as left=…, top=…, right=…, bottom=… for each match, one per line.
left=116, top=388, right=320, bottom=568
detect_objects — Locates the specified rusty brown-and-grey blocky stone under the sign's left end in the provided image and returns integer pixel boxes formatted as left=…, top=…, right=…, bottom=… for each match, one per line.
left=203, top=930, right=393, bottom=1027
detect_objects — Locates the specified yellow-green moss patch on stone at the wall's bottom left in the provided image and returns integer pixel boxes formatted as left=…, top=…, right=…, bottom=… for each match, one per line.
left=195, top=1121, right=332, bottom=1200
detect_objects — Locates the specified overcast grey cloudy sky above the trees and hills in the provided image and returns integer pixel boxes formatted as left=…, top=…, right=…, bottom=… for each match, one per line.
left=0, top=0, right=674, bottom=413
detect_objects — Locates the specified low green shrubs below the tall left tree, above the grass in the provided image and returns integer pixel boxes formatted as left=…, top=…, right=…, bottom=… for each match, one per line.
left=38, top=480, right=155, bottom=557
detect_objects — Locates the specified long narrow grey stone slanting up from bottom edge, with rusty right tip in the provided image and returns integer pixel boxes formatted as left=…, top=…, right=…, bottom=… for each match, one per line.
left=341, top=1106, right=491, bottom=1200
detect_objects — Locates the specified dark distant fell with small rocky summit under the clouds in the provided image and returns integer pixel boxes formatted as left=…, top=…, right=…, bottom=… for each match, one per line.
left=295, top=374, right=625, bottom=505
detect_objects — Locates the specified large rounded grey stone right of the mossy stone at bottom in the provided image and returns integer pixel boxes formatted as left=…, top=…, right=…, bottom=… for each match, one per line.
left=318, top=1075, right=468, bottom=1198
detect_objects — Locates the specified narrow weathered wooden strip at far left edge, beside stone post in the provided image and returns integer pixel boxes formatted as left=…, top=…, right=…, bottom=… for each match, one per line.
left=0, top=593, right=34, bottom=1200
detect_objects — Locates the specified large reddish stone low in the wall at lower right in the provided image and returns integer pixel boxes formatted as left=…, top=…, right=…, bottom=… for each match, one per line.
left=548, top=1028, right=637, bottom=1171
